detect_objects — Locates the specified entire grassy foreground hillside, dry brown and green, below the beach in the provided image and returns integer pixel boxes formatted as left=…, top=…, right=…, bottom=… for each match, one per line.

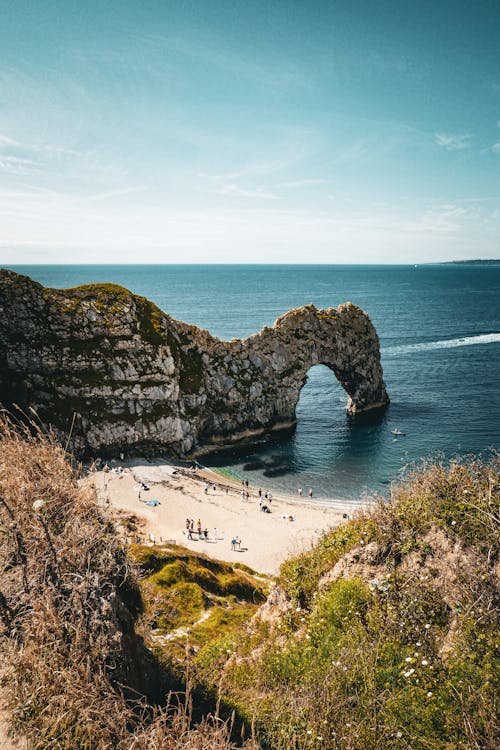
left=0, top=424, right=500, bottom=750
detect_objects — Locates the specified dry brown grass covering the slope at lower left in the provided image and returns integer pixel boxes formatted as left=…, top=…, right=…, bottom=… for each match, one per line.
left=0, top=418, right=258, bottom=750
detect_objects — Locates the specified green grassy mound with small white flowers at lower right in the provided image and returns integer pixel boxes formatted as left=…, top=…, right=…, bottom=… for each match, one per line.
left=215, top=459, right=500, bottom=750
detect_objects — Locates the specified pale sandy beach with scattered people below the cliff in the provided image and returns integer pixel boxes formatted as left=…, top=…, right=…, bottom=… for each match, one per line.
left=85, top=460, right=361, bottom=575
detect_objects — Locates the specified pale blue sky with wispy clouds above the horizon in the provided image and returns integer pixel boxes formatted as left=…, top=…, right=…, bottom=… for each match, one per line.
left=0, top=0, right=500, bottom=265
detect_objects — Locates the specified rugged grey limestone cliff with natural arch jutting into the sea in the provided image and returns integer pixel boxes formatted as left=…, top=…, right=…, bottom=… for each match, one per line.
left=0, top=270, right=389, bottom=456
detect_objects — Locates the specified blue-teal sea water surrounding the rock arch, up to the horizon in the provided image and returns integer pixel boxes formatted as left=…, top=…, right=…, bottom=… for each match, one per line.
left=7, top=265, right=500, bottom=506
